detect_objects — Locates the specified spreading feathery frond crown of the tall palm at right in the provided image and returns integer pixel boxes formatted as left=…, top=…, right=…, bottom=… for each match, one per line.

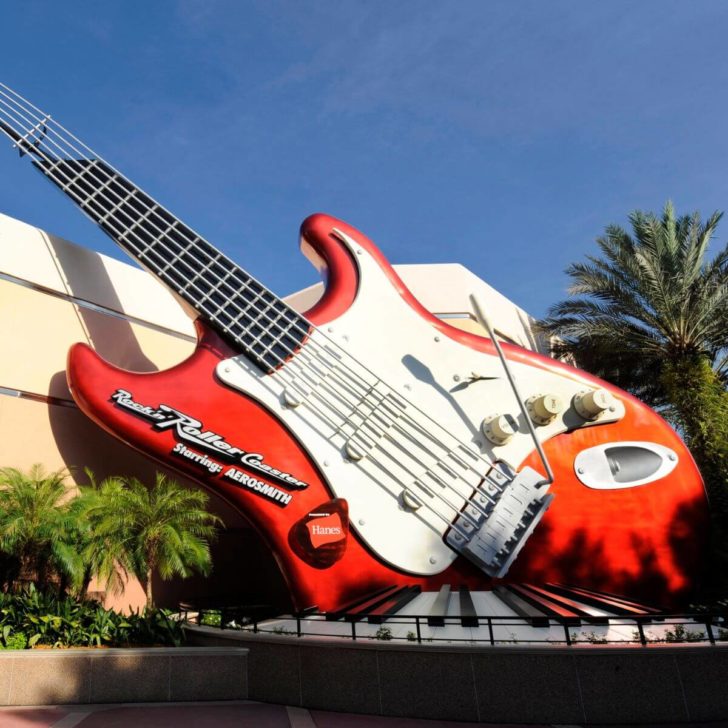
left=536, top=202, right=728, bottom=407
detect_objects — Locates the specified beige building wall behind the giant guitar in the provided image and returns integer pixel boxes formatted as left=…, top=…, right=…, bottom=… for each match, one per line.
left=0, top=214, right=544, bottom=608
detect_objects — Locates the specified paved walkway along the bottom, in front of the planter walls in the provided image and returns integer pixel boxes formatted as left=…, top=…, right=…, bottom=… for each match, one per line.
left=0, top=701, right=728, bottom=728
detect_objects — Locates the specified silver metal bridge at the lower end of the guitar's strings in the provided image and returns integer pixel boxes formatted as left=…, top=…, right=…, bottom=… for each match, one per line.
left=445, top=468, right=553, bottom=578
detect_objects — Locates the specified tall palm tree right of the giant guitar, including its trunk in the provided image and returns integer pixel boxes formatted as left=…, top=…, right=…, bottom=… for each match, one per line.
left=538, top=202, right=728, bottom=504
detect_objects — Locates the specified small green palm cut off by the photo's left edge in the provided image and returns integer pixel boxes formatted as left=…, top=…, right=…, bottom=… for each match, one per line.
left=0, top=464, right=83, bottom=589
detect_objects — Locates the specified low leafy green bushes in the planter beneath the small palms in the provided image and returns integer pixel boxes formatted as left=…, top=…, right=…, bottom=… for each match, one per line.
left=0, top=585, right=184, bottom=649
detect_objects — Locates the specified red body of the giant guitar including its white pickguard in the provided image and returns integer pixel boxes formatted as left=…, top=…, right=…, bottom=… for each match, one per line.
left=68, top=215, right=707, bottom=610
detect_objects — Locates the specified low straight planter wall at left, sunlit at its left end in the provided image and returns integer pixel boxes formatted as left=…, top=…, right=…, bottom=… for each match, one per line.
left=0, top=645, right=248, bottom=705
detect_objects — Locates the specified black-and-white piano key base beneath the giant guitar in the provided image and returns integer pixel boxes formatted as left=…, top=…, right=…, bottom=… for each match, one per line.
left=237, top=584, right=728, bottom=647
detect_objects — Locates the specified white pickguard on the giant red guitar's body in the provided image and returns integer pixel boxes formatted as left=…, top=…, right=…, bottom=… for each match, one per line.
left=217, top=233, right=624, bottom=575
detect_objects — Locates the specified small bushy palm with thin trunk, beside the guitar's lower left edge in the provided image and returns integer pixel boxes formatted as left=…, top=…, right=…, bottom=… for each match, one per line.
left=84, top=473, right=220, bottom=609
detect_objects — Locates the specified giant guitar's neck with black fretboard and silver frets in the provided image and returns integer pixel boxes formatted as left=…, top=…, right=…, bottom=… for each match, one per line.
left=0, top=84, right=310, bottom=371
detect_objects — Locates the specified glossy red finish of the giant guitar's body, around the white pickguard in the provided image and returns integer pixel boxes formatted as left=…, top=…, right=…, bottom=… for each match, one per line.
left=68, top=215, right=707, bottom=610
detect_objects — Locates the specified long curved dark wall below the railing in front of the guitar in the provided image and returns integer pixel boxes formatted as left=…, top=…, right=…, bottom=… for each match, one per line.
left=188, top=627, right=728, bottom=725
